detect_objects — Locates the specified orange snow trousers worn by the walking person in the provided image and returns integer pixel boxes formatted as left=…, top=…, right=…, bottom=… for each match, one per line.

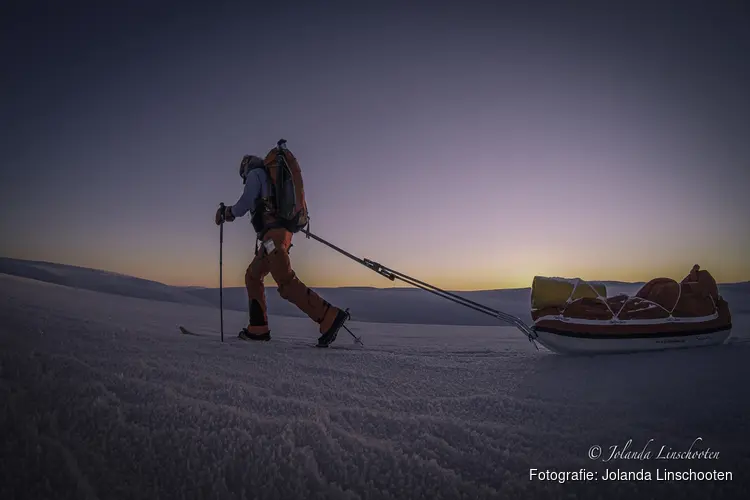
left=245, top=229, right=339, bottom=335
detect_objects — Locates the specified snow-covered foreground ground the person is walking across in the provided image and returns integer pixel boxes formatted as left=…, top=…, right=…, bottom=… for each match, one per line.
left=0, top=275, right=750, bottom=500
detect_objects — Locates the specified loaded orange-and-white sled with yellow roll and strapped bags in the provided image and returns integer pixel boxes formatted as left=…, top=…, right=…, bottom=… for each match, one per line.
left=531, top=266, right=732, bottom=353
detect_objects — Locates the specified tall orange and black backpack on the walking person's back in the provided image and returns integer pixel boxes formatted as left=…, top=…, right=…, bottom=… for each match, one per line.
left=263, top=139, right=310, bottom=233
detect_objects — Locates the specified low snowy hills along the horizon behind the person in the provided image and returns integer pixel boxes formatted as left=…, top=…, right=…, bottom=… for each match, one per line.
left=0, top=257, right=750, bottom=326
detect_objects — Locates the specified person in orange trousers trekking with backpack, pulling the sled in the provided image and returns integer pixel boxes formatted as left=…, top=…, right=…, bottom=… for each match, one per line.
left=216, top=139, right=349, bottom=347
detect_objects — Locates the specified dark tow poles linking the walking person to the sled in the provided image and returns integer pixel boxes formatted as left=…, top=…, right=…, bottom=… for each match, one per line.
left=301, top=229, right=539, bottom=349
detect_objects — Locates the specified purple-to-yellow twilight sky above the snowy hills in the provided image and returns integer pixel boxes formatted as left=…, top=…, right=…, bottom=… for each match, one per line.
left=0, top=0, right=750, bottom=289
